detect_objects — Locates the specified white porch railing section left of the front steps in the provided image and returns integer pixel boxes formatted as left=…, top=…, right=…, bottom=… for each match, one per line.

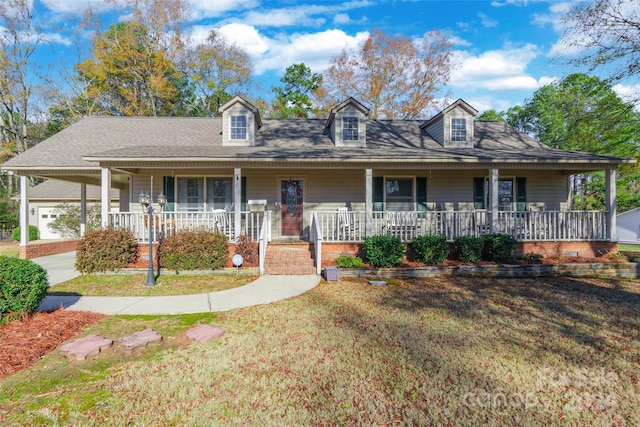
left=109, top=212, right=265, bottom=243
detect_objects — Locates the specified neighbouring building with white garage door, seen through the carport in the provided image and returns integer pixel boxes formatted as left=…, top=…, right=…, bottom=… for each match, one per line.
left=19, top=179, right=119, bottom=240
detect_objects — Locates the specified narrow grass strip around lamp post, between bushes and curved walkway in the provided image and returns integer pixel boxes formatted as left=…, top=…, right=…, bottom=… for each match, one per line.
left=49, top=274, right=257, bottom=296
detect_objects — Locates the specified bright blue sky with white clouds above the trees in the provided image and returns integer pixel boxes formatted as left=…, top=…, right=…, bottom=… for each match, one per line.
left=20, top=0, right=634, bottom=111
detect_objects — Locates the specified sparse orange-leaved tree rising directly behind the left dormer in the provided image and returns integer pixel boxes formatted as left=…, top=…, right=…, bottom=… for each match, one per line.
left=185, top=30, right=253, bottom=116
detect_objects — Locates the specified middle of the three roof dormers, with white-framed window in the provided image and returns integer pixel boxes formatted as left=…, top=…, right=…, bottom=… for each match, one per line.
left=325, top=98, right=369, bottom=147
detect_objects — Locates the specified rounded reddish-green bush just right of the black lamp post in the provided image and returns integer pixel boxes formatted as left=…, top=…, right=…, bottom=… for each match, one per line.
left=158, top=229, right=229, bottom=272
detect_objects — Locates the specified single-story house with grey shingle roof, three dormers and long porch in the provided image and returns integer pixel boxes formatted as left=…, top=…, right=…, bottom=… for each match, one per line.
left=2, top=97, right=634, bottom=268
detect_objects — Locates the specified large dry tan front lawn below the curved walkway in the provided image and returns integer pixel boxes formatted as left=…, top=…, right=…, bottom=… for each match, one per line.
left=0, top=279, right=640, bottom=426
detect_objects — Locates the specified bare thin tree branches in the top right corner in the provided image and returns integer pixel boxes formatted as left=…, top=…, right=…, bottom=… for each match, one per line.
left=562, top=0, right=640, bottom=92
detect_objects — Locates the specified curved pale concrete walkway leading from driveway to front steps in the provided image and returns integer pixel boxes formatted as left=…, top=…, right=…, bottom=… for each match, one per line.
left=33, top=252, right=320, bottom=315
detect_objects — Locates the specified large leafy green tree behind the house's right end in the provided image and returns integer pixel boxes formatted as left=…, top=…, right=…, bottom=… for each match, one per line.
left=507, top=74, right=640, bottom=210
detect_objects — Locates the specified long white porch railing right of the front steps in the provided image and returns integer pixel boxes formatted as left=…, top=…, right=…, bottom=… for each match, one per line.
left=314, top=210, right=607, bottom=242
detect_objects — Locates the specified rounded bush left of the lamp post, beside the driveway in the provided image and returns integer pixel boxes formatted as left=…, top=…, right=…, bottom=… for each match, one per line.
left=76, top=228, right=139, bottom=273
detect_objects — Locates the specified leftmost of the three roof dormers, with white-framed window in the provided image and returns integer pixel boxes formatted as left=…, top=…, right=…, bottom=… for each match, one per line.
left=220, top=96, right=262, bottom=147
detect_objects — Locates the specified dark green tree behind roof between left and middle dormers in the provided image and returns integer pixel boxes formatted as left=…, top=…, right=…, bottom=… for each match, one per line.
left=271, top=63, right=322, bottom=119
